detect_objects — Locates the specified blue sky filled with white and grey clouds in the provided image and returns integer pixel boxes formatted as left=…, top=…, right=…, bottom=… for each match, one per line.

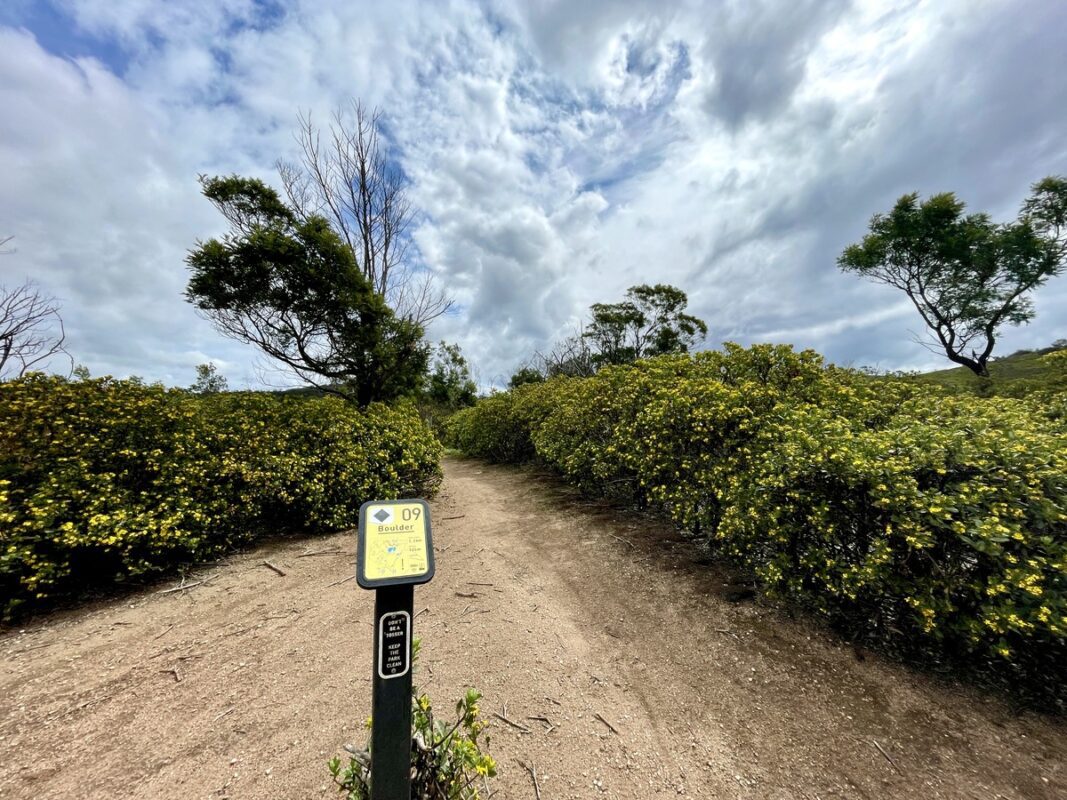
left=0, top=0, right=1067, bottom=386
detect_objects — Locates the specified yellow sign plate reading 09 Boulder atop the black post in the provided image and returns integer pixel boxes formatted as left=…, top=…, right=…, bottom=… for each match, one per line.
left=355, top=500, right=433, bottom=589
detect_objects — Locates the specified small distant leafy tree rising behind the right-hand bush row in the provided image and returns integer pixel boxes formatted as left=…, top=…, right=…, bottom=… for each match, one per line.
left=583, top=284, right=707, bottom=367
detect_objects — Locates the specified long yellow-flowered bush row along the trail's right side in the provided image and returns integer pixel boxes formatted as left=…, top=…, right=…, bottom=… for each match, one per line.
left=449, top=346, right=1067, bottom=682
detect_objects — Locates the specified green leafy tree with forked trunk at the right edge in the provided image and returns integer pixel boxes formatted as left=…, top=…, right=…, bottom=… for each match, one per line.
left=838, top=177, right=1067, bottom=377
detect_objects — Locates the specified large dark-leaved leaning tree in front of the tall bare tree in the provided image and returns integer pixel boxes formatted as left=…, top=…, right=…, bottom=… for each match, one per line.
left=186, top=175, right=429, bottom=405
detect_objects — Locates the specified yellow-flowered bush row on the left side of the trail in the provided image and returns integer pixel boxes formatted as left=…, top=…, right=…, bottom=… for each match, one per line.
left=0, top=375, right=440, bottom=615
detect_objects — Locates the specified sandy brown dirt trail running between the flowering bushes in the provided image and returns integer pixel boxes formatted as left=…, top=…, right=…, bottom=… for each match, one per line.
left=0, top=460, right=1067, bottom=800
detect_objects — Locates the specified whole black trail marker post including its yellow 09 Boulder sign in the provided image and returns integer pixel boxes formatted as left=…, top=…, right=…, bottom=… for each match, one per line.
left=355, top=499, right=434, bottom=800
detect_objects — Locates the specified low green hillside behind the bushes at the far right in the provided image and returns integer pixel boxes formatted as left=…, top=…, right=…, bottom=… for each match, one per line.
left=907, top=347, right=1067, bottom=396
